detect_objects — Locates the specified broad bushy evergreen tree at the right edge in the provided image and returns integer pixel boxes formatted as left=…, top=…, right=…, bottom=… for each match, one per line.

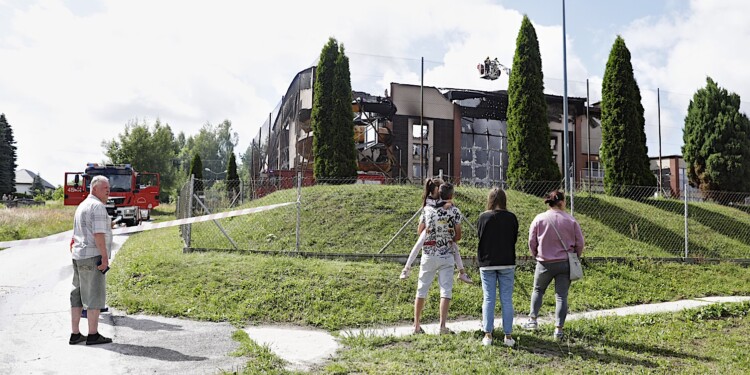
left=682, top=77, right=750, bottom=203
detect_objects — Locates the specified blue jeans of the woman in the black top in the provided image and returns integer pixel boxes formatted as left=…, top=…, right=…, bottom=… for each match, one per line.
left=479, top=268, right=516, bottom=335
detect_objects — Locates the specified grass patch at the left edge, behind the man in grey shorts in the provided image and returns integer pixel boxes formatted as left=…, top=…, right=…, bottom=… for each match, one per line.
left=0, top=201, right=75, bottom=241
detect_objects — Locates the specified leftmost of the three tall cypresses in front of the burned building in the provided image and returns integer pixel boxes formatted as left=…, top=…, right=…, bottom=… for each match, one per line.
left=311, top=38, right=357, bottom=183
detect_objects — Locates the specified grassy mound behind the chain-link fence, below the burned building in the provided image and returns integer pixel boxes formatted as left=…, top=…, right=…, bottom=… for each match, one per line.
left=191, top=185, right=750, bottom=258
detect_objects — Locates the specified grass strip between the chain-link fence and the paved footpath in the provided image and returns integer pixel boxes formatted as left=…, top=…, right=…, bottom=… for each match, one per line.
left=108, top=228, right=750, bottom=330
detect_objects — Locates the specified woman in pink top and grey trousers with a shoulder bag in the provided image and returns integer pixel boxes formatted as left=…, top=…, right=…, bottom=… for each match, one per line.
left=523, top=191, right=583, bottom=340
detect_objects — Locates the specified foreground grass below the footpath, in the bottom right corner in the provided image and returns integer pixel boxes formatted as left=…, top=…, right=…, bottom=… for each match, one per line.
left=308, top=303, right=750, bottom=374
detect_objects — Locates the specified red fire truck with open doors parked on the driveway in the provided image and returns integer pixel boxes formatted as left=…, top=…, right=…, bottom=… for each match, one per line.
left=64, top=163, right=159, bottom=226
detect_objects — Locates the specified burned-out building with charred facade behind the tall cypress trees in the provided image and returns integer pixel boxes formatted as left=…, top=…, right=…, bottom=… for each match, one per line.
left=251, top=67, right=601, bottom=184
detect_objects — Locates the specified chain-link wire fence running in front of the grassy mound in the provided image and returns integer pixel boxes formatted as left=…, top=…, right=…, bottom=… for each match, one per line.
left=177, top=177, right=750, bottom=260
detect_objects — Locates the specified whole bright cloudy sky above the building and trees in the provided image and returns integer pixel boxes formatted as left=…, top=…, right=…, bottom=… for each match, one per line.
left=0, top=0, right=750, bottom=185
